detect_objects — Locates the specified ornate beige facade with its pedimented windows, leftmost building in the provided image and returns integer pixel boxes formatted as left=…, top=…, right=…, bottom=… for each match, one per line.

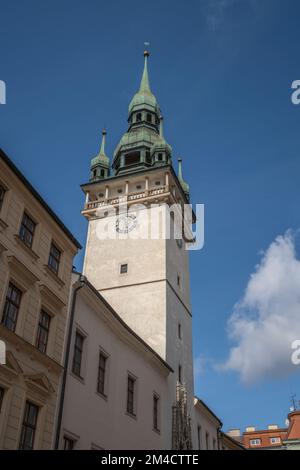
left=0, top=150, right=80, bottom=449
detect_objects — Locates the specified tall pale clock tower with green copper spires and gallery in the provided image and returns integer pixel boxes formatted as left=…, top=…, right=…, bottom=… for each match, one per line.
left=82, top=51, right=193, bottom=444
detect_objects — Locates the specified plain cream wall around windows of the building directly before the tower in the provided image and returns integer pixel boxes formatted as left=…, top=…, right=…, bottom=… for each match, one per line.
left=60, top=280, right=171, bottom=449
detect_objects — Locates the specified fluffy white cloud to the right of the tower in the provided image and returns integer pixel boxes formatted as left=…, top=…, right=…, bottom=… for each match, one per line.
left=222, top=231, right=300, bottom=384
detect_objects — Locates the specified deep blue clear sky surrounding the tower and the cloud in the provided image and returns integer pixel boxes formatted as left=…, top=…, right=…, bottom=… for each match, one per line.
left=0, top=0, right=300, bottom=429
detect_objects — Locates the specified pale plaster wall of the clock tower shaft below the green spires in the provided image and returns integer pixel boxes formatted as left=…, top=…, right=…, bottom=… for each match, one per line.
left=83, top=175, right=194, bottom=440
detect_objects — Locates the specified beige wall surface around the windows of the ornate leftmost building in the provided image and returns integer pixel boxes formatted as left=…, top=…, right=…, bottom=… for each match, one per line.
left=0, top=158, right=76, bottom=449
